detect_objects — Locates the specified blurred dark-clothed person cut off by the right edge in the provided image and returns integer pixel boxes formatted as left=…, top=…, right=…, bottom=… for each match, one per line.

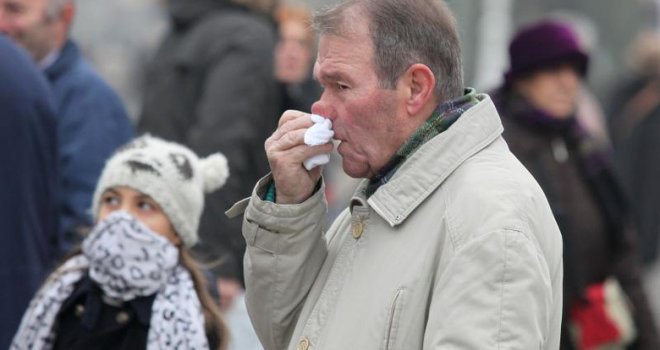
left=608, top=28, right=660, bottom=330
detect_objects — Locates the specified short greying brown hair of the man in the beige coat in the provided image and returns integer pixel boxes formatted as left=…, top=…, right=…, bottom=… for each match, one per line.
left=314, top=0, right=463, bottom=102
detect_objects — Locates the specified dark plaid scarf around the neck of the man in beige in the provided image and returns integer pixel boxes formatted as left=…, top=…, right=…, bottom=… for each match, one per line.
left=365, top=88, right=479, bottom=197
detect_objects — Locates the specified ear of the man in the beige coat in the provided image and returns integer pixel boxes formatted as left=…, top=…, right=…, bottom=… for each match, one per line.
left=404, top=63, right=435, bottom=115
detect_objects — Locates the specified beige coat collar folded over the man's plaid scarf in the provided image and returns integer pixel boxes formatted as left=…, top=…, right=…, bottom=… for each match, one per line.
left=351, top=94, right=503, bottom=227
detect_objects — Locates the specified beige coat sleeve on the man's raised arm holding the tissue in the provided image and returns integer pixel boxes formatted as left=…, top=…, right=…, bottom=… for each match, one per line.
left=243, top=178, right=328, bottom=350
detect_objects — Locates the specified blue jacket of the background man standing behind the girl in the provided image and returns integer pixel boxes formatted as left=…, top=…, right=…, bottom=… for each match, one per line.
left=45, top=40, right=133, bottom=254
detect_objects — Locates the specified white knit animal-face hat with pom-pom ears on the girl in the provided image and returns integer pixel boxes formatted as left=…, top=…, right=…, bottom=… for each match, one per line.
left=92, top=135, right=229, bottom=248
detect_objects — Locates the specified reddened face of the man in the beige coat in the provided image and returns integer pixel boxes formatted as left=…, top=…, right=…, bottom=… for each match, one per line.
left=312, top=22, right=406, bottom=178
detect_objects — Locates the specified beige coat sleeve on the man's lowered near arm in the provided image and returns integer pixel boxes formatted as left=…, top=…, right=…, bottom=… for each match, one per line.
left=424, top=229, right=562, bottom=350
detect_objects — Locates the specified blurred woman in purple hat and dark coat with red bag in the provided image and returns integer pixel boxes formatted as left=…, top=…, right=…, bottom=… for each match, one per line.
left=493, top=21, right=660, bottom=350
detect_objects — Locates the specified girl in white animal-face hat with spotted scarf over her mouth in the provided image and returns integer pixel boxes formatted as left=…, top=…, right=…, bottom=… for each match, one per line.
left=11, top=135, right=229, bottom=350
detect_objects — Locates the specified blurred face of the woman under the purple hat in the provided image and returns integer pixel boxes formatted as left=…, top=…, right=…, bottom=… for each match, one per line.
left=517, top=64, right=582, bottom=119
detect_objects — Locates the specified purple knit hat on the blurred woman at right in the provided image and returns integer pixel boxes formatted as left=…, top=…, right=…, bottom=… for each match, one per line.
left=504, top=20, right=589, bottom=85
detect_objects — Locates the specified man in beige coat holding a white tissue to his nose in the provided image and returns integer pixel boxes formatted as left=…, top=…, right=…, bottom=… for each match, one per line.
left=228, top=0, right=563, bottom=350
